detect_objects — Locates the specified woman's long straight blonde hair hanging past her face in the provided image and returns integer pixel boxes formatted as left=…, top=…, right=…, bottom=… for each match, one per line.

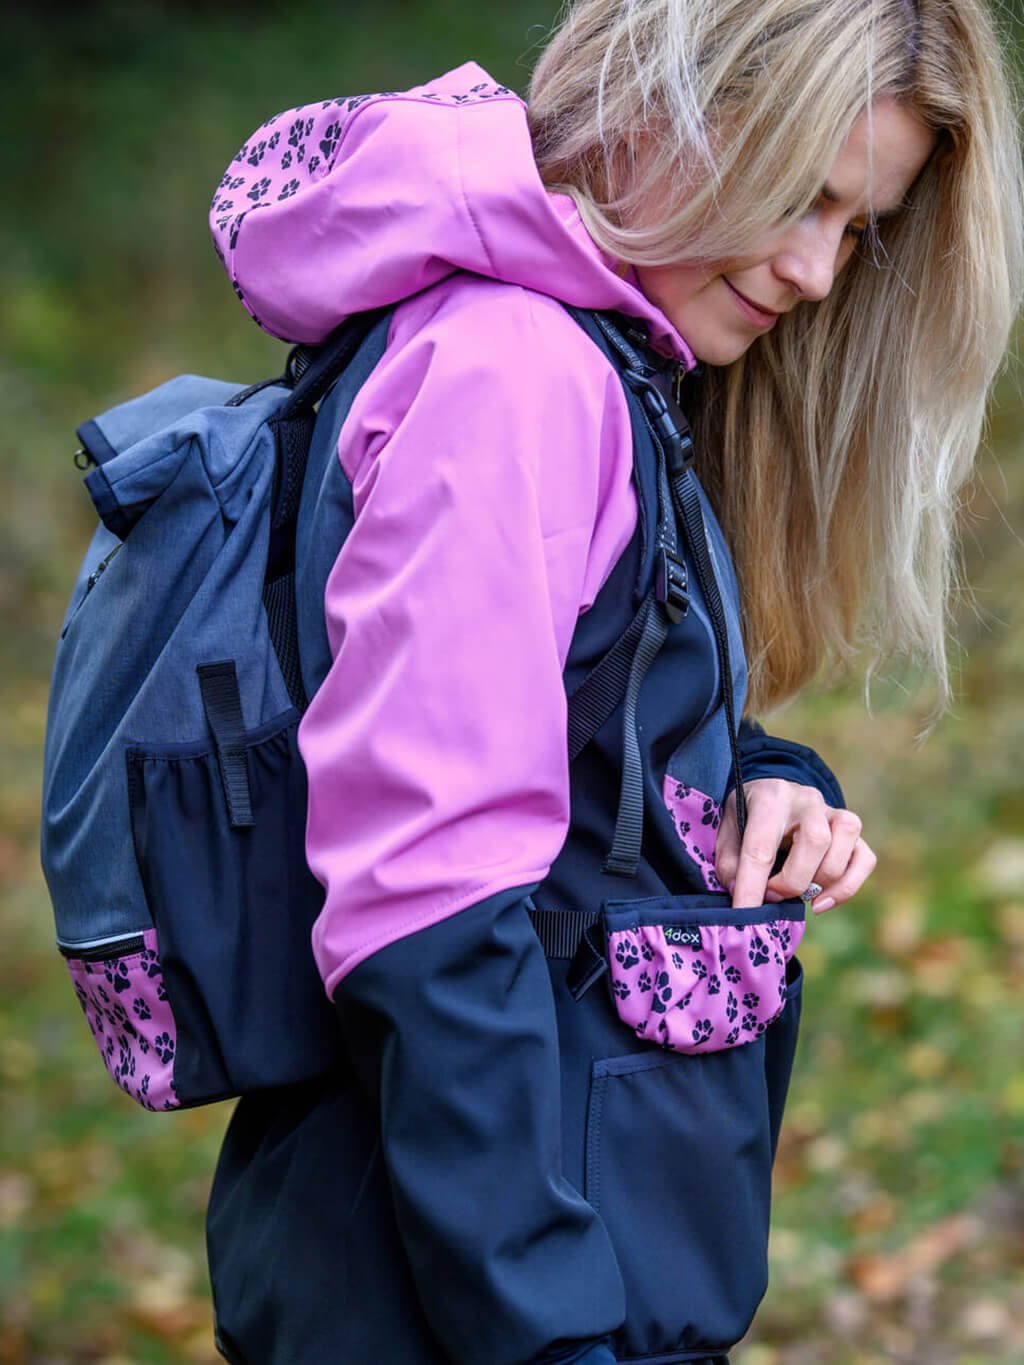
left=528, top=0, right=1024, bottom=713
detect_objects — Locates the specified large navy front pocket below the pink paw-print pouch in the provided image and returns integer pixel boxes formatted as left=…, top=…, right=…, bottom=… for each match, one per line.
left=583, top=960, right=800, bottom=1365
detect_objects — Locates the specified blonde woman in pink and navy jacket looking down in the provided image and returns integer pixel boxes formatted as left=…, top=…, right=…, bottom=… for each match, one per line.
left=209, top=0, right=1021, bottom=1365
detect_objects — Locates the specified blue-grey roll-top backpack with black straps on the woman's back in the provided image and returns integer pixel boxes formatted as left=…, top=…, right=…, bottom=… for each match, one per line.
left=42, top=298, right=743, bottom=1110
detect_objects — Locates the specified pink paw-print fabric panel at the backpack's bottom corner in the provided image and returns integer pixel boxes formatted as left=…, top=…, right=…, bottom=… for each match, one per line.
left=68, top=931, right=180, bottom=1110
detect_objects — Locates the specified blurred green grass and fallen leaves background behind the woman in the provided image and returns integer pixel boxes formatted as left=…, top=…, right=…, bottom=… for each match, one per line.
left=0, top=0, right=1024, bottom=1365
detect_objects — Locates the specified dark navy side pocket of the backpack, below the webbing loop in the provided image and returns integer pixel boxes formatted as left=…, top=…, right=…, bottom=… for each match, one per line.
left=127, top=710, right=340, bottom=1104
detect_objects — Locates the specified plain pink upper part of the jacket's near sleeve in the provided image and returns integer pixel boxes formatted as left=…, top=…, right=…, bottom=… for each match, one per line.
left=294, top=276, right=636, bottom=995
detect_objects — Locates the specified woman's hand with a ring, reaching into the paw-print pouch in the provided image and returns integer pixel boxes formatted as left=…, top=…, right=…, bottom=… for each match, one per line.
left=715, top=778, right=878, bottom=915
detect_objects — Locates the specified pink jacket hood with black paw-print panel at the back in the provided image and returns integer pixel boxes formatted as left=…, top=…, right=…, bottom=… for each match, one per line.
left=210, top=61, right=695, bottom=367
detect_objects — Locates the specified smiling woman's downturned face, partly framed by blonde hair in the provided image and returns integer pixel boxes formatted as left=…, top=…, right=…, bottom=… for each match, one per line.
left=636, top=98, right=935, bottom=364
